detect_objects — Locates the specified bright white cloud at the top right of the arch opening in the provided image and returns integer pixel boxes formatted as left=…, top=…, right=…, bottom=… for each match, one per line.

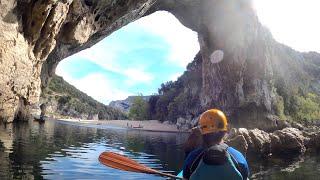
left=133, top=11, right=200, bottom=68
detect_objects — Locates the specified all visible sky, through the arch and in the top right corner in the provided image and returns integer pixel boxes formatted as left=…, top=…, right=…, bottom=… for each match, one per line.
left=56, top=0, right=320, bottom=104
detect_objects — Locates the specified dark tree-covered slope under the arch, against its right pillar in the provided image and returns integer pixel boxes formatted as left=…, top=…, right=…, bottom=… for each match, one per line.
left=149, top=54, right=202, bottom=122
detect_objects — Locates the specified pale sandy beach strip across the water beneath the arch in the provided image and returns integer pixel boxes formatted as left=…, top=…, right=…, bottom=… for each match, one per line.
left=57, top=119, right=185, bottom=132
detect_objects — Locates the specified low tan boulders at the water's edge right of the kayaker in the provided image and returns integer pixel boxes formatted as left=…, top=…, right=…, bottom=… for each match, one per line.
left=227, top=128, right=312, bottom=156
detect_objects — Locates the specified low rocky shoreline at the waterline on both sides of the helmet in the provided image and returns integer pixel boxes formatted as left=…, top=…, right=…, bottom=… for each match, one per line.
left=176, top=117, right=320, bottom=157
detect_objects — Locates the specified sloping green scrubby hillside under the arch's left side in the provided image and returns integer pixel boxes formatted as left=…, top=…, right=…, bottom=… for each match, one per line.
left=41, top=75, right=127, bottom=119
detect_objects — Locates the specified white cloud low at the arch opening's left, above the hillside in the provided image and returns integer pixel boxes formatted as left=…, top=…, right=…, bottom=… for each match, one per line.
left=56, top=68, right=131, bottom=104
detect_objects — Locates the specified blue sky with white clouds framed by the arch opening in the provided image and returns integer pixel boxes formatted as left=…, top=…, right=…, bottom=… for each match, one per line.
left=56, top=12, right=199, bottom=104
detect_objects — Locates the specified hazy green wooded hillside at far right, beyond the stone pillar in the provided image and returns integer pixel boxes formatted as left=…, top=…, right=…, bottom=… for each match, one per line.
left=274, top=50, right=320, bottom=121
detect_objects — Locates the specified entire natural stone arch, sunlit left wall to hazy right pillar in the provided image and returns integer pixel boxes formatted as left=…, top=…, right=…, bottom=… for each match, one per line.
left=0, top=0, right=319, bottom=126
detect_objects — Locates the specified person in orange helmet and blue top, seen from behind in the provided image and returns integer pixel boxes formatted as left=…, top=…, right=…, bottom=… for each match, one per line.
left=183, top=109, right=249, bottom=180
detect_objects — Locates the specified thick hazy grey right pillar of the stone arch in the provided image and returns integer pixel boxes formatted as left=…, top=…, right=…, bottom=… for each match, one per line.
left=149, top=0, right=276, bottom=128
